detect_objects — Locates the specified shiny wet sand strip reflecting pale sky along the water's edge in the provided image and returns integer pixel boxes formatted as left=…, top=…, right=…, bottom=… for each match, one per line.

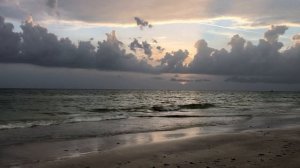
left=1, top=128, right=225, bottom=165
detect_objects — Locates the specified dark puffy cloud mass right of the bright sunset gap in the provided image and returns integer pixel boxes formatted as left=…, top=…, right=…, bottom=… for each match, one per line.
left=188, top=26, right=300, bottom=76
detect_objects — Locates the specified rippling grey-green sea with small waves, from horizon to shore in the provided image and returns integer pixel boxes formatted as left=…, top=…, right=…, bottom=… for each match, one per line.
left=0, top=89, right=300, bottom=146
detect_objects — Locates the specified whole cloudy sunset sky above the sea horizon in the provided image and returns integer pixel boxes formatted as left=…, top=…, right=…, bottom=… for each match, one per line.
left=0, top=0, right=300, bottom=91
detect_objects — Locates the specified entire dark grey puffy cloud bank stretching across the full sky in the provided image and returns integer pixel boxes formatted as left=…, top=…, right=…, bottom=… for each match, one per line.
left=0, top=17, right=300, bottom=83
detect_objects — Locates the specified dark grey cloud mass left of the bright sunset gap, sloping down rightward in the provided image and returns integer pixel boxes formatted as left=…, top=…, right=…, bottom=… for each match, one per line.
left=0, top=17, right=153, bottom=72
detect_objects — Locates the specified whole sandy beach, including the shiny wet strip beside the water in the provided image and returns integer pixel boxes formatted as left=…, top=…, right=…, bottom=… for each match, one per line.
left=2, top=126, right=300, bottom=168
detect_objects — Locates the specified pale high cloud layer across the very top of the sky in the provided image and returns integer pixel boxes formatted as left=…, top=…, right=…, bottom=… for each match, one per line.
left=0, top=0, right=300, bottom=26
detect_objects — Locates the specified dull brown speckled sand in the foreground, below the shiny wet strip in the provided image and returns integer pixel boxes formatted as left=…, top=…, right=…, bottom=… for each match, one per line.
left=25, top=127, right=300, bottom=168
